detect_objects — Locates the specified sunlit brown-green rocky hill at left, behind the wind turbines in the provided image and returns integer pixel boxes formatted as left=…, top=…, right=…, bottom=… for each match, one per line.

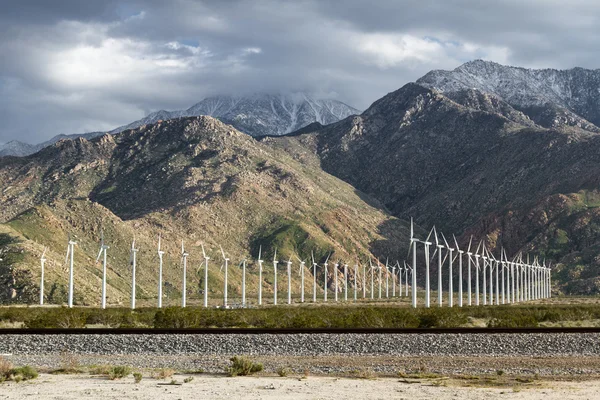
left=0, top=117, right=408, bottom=305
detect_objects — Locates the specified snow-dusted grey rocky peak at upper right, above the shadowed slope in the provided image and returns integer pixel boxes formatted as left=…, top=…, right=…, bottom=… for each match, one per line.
left=417, top=60, right=600, bottom=133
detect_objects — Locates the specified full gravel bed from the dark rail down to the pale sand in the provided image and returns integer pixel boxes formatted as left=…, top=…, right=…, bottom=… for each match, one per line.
left=0, top=333, right=600, bottom=376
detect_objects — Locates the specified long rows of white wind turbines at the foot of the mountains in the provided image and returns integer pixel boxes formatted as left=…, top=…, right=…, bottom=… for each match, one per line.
left=39, top=221, right=552, bottom=309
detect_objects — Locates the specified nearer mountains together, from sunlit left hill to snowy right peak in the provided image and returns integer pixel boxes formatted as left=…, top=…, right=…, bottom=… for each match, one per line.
left=0, top=61, right=600, bottom=304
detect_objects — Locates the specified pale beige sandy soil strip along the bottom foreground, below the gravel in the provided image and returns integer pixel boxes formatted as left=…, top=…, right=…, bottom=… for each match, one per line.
left=0, top=374, right=600, bottom=400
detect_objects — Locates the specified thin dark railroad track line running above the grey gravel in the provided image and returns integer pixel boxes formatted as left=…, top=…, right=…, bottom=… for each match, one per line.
left=0, top=327, right=600, bottom=336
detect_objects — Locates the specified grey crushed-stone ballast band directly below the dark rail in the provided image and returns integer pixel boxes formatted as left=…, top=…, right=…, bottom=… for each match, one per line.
left=0, top=333, right=600, bottom=356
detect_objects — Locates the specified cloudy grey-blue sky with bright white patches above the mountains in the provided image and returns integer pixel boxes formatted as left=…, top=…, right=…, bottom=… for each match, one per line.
left=0, top=0, right=600, bottom=143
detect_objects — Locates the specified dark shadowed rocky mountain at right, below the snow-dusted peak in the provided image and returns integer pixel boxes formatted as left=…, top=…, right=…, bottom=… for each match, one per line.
left=266, top=83, right=600, bottom=293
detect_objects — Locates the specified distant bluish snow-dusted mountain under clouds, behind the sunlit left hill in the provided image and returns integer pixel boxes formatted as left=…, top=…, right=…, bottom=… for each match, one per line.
left=0, top=92, right=360, bottom=157
